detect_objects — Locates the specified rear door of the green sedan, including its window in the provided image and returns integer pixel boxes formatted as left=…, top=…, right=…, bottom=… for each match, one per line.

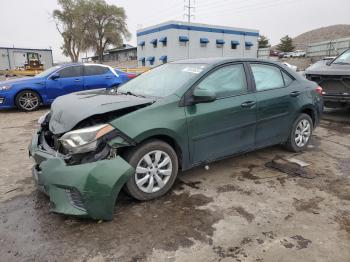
left=250, top=63, right=303, bottom=147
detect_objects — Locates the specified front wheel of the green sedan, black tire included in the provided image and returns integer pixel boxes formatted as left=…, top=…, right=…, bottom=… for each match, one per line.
left=125, top=139, right=178, bottom=200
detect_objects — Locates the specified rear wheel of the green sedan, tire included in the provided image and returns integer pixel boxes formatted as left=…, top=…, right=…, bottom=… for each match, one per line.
left=286, top=113, right=313, bottom=152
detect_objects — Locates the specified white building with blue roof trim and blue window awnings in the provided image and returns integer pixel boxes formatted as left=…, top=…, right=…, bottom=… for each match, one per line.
left=137, top=21, right=259, bottom=66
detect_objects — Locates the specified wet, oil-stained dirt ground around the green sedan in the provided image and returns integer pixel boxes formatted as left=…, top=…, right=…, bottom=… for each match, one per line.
left=0, top=109, right=350, bottom=262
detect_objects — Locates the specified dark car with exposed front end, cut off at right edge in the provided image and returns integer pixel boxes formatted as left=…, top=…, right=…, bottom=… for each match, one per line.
left=305, top=49, right=350, bottom=108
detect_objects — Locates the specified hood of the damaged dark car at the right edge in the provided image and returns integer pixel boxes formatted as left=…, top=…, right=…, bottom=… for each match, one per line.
left=305, top=60, right=350, bottom=75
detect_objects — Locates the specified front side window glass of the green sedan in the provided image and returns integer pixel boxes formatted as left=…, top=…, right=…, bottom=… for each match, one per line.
left=197, top=64, right=247, bottom=98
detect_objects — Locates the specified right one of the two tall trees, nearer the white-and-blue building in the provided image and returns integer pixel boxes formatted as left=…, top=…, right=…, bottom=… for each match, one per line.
left=87, top=0, right=130, bottom=61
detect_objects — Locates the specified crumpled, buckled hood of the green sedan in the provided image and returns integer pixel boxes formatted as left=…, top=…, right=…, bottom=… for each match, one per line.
left=49, top=89, right=155, bottom=134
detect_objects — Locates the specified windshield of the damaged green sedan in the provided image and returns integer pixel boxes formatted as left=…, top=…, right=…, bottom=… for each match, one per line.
left=118, top=64, right=207, bottom=97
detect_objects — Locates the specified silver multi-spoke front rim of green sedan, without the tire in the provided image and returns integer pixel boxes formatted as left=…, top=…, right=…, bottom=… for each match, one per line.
left=135, top=150, right=173, bottom=193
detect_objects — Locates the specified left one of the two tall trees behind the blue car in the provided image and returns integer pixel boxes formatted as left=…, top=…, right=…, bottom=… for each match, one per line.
left=52, top=0, right=88, bottom=62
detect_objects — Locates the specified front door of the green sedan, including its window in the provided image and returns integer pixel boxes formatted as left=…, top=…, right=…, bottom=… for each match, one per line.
left=185, top=63, right=256, bottom=165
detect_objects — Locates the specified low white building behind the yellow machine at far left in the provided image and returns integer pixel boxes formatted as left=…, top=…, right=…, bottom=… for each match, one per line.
left=0, top=47, right=53, bottom=70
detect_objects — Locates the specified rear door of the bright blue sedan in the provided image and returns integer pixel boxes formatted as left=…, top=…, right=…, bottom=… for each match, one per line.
left=84, top=65, right=117, bottom=89
